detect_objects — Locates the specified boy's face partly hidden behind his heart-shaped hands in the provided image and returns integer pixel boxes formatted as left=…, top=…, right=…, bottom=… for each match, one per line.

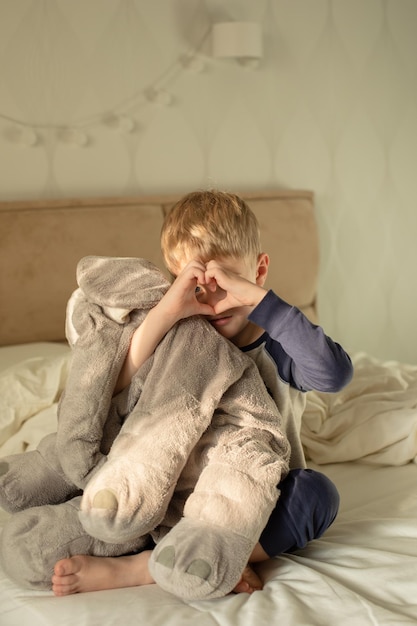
left=174, top=252, right=264, bottom=346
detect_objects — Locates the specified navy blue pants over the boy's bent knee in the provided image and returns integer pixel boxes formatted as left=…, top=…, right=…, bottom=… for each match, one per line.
left=259, top=469, right=340, bottom=557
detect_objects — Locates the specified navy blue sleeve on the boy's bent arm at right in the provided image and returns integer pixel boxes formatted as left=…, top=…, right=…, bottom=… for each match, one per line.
left=249, top=290, right=353, bottom=392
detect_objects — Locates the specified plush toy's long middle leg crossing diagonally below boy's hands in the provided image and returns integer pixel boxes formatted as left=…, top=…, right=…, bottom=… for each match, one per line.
left=80, top=318, right=250, bottom=542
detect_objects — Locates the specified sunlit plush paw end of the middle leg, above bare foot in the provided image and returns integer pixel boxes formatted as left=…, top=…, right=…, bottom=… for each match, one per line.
left=79, top=458, right=175, bottom=543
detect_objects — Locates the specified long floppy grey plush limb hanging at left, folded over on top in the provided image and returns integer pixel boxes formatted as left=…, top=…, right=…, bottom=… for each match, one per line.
left=57, top=257, right=169, bottom=489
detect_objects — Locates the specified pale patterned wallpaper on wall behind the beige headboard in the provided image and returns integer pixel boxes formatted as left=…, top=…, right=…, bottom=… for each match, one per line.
left=0, top=0, right=417, bottom=363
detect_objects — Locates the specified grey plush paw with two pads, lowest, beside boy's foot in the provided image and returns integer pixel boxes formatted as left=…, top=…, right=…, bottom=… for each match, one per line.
left=149, top=518, right=254, bottom=600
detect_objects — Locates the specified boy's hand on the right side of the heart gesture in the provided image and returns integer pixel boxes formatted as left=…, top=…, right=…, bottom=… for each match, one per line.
left=205, top=261, right=267, bottom=315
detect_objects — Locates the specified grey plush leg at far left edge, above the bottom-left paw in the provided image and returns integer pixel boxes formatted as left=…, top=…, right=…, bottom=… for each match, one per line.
left=0, top=433, right=80, bottom=513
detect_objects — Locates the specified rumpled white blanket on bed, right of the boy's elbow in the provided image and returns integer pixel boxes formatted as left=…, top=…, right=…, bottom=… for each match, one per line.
left=302, top=353, right=417, bottom=465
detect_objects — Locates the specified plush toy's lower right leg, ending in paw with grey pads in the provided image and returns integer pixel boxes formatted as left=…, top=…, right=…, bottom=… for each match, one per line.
left=150, top=368, right=289, bottom=600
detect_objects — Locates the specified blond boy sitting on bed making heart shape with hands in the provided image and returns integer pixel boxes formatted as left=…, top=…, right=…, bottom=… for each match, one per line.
left=52, top=191, right=352, bottom=595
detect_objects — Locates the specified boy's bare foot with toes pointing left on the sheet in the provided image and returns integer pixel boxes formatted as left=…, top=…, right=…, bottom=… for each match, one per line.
left=52, top=550, right=155, bottom=596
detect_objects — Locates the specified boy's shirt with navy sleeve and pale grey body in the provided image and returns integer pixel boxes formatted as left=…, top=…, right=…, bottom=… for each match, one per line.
left=241, top=291, right=353, bottom=468
